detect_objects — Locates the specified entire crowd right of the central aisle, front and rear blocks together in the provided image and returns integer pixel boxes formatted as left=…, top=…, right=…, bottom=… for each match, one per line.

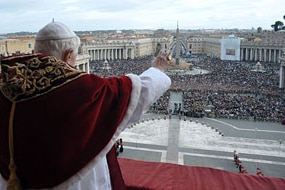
left=179, top=57, right=285, bottom=122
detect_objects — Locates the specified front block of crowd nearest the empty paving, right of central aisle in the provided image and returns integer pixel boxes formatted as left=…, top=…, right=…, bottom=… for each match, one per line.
left=183, top=90, right=284, bottom=122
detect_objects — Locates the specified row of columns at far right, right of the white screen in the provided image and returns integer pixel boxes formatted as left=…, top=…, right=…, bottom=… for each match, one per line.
left=240, top=47, right=281, bottom=63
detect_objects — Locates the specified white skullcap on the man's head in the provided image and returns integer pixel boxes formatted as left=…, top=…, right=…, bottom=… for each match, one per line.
left=36, top=22, right=76, bottom=41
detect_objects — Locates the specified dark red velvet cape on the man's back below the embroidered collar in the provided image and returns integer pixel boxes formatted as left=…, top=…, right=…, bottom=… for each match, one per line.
left=0, top=53, right=132, bottom=188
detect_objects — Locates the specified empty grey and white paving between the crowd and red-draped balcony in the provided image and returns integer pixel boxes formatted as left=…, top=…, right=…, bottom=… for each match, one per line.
left=119, top=114, right=285, bottom=178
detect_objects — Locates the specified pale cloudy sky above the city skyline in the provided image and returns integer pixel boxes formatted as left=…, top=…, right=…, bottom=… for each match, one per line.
left=0, top=0, right=285, bottom=34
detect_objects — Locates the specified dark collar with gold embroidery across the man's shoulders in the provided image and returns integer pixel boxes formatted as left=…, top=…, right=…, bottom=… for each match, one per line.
left=0, top=54, right=86, bottom=102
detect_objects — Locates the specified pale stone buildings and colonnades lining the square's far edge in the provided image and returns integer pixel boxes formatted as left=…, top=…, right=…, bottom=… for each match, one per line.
left=0, top=28, right=285, bottom=75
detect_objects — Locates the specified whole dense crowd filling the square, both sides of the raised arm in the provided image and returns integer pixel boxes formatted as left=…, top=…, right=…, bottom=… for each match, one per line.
left=90, top=56, right=285, bottom=122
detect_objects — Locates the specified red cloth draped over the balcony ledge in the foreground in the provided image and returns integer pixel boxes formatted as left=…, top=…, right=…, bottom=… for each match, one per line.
left=118, top=158, right=285, bottom=190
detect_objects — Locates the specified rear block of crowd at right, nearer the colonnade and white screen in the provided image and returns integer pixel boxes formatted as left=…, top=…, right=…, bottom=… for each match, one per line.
left=173, top=57, right=280, bottom=94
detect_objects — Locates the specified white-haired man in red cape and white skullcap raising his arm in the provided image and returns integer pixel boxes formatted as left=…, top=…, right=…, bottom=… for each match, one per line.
left=0, top=22, right=172, bottom=190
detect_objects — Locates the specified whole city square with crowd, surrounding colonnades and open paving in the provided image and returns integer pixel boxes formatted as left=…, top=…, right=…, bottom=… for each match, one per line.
left=0, top=18, right=285, bottom=189
